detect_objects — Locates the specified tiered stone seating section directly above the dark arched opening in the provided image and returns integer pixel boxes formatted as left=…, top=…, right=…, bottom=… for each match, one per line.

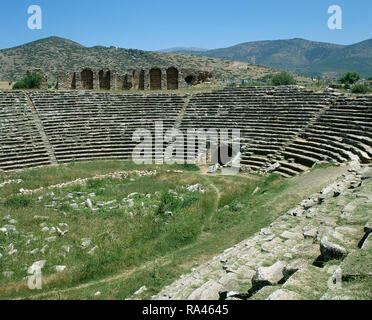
left=181, top=87, right=334, bottom=169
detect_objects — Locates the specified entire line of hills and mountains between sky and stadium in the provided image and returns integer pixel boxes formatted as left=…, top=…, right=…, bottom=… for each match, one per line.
left=0, top=37, right=372, bottom=81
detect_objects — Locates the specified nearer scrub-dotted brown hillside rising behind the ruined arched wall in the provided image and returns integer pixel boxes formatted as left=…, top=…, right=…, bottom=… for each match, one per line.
left=0, top=36, right=278, bottom=82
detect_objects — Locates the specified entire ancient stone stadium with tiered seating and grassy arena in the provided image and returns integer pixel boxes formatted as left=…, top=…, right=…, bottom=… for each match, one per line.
left=0, top=84, right=372, bottom=300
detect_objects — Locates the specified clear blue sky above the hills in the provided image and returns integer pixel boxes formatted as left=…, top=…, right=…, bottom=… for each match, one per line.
left=0, top=0, right=372, bottom=50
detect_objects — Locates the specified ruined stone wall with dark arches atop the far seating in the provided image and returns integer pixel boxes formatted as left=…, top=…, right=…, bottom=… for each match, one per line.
left=58, top=67, right=214, bottom=90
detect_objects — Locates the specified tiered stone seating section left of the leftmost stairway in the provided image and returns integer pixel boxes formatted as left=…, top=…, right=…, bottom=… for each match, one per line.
left=0, top=91, right=50, bottom=170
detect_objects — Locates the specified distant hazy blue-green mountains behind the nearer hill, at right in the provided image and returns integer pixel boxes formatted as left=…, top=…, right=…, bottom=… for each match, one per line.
left=161, top=38, right=372, bottom=78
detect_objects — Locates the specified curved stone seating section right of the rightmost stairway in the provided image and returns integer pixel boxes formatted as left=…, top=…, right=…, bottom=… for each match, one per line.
left=278, top=96, right=372, bottom=175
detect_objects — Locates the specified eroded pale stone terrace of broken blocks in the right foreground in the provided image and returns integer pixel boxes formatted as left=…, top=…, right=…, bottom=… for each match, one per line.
left=153, top=165, right=372, bottom=300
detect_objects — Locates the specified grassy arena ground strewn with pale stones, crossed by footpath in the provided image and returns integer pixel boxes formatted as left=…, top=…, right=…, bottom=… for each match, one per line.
left=0, top=161, right=347, bottom=299
